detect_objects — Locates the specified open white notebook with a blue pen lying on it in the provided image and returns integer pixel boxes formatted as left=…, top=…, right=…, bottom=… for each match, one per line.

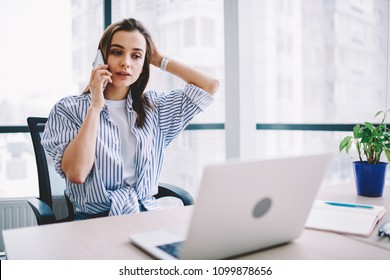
left=306, top=200, right=386, bottom=236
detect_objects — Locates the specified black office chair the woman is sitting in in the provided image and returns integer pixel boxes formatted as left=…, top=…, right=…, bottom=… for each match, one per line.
left=27, top=117, right=194, bottom=225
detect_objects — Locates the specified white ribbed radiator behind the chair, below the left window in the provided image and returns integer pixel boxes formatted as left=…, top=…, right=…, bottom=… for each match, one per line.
left=0, top=197, right=68, bottom=252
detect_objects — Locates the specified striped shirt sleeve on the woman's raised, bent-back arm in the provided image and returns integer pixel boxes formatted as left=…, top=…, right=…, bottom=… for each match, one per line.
left=151, top=84, right=214, bottom=147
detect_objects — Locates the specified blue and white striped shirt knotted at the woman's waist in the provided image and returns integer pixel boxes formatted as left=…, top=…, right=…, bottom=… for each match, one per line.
left=41, top=84, right=213, bottom=215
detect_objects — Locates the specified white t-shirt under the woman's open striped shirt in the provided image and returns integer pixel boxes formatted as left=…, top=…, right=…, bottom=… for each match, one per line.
left=106, top=99, right=137, bottom=185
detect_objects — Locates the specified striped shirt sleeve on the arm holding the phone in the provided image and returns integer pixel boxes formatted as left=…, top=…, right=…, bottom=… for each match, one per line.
left=41, top=100, right=79, bottom=178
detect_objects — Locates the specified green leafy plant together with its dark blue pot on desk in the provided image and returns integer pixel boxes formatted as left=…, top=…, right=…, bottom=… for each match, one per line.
left=339, top=109, right=390, bottom=197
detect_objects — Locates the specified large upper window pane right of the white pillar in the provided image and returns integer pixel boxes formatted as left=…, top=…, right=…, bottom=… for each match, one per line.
left=248, top=0, right=388, bottom=123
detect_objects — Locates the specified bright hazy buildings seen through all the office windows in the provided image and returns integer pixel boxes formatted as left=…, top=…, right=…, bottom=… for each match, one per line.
left=0, top=0, right=389, bottom=198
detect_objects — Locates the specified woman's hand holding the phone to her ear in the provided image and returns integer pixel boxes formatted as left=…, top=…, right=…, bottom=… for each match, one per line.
left=89, top=65, right=112, bottom=109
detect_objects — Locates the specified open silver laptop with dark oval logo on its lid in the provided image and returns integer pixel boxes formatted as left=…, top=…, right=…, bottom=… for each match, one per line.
left=130, top=154, right=332, bottom=260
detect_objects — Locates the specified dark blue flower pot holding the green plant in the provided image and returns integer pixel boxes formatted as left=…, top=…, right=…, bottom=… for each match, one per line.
left=353, top=161, right=388, bottom=197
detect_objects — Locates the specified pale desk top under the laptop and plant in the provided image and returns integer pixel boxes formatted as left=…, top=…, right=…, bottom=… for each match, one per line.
left=3, top=185, right=390, bottom=260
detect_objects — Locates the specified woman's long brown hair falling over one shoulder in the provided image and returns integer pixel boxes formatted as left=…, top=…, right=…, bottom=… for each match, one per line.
left=83, top=18, right=153, bottom=127
